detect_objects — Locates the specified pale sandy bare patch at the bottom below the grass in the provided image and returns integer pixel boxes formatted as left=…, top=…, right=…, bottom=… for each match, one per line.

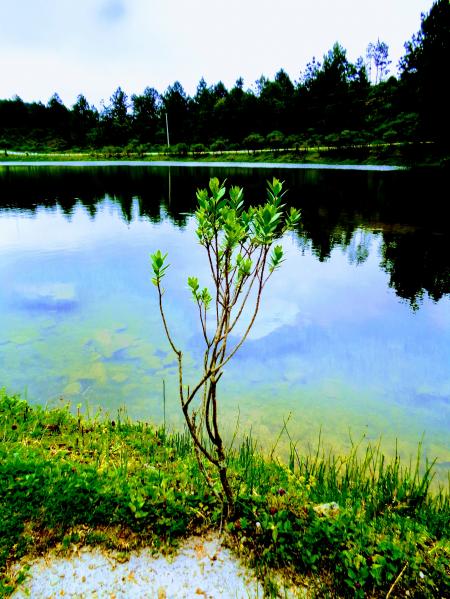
left=12, top=535, right=264, bottom=599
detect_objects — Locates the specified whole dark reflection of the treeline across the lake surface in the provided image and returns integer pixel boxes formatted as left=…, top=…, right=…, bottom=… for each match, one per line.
left=0, top=164, right=450, bottom=307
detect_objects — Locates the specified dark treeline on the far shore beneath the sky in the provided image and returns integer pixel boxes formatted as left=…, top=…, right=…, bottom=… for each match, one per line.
left=0, top=0, right=450, bottom=153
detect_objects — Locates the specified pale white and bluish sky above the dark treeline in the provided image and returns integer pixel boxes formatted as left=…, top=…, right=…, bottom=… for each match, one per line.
left=0, top=0, right=433, bottom=108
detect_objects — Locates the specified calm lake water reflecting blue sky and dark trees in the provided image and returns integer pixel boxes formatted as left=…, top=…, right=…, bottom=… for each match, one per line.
left=0, top=163, right=450, bottom=472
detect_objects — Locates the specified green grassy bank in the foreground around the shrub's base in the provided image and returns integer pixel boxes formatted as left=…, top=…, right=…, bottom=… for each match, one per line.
left=0, top=391, right=450, bottom=597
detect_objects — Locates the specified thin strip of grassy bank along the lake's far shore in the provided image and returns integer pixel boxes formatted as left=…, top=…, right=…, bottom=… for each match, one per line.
left=0, top=143, right=450, bottom=167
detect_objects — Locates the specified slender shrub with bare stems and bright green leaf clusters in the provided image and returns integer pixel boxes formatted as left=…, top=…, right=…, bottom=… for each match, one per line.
left=151, top=178, right=300, bottom=516
